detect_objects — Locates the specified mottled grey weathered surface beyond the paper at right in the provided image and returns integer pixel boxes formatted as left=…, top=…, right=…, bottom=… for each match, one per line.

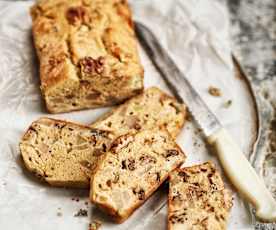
left=223, top=0, right=276, bottom=229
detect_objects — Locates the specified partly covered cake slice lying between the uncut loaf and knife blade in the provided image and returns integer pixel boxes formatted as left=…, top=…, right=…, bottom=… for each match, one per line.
left=91, top=87, right=186, bottom=138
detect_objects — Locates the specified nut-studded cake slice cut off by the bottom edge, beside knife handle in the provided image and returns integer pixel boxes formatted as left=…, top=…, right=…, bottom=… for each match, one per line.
left=168, top=162, right=232, bottom=230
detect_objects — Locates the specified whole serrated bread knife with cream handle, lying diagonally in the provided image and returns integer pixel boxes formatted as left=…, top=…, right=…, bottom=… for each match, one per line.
left=135, top=23, right=276, bottom=222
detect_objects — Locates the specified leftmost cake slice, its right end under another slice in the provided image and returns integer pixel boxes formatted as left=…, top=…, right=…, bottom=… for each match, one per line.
left=19, top=118, right=113, bottom=187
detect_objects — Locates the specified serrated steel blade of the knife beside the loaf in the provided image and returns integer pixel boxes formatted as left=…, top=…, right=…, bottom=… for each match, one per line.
left=136, top=23, right=222, bottom=137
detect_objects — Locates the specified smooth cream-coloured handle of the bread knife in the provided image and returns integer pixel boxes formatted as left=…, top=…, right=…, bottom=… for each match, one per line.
left=208, top=128, right=276, bottom=222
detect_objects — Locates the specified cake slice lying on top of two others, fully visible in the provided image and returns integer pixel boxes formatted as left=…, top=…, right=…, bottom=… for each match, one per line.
left=90, top=129, right=185, bottom=223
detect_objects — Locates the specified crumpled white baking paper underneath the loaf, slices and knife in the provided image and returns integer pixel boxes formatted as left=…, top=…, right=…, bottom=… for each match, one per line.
left=0, top=0, right=256, bottom=230
